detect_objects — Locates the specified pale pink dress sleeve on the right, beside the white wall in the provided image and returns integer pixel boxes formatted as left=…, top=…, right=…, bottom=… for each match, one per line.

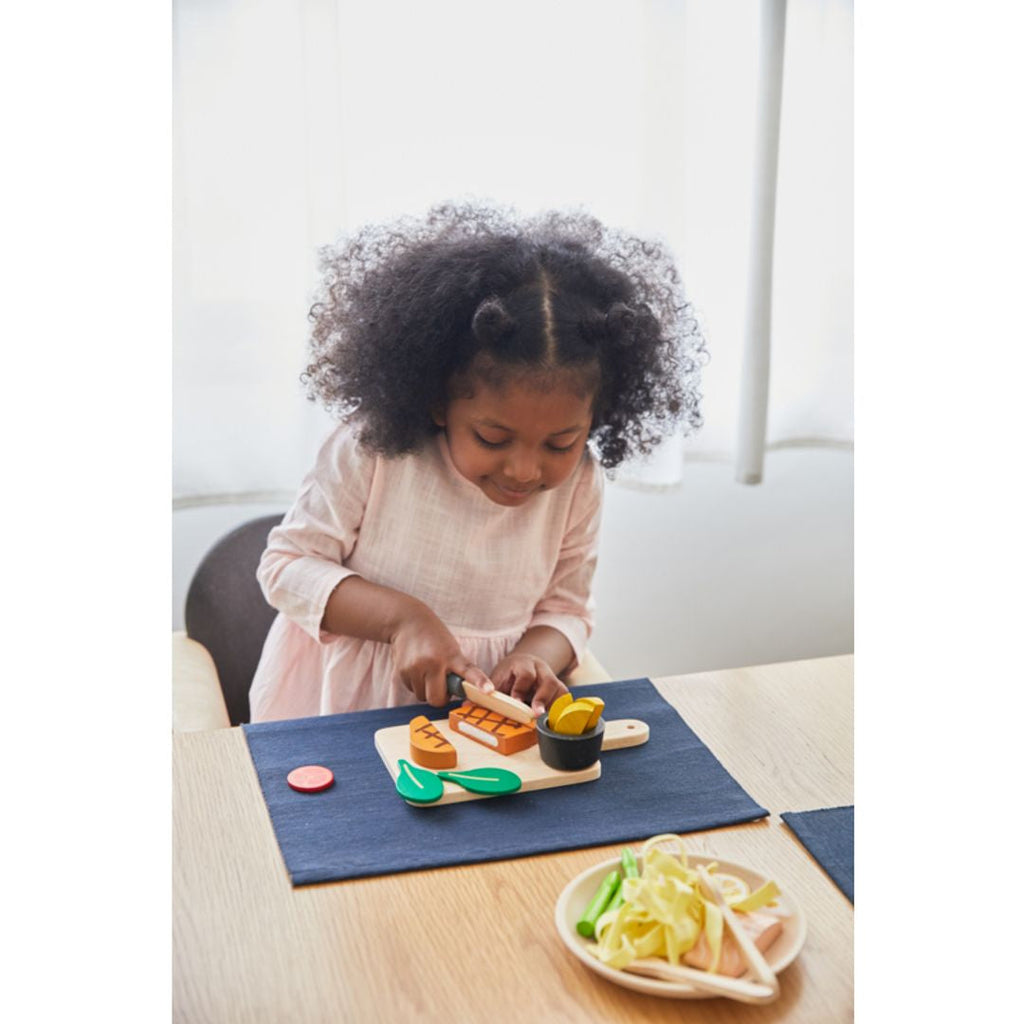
left=529, top=457, right=604, bottom=669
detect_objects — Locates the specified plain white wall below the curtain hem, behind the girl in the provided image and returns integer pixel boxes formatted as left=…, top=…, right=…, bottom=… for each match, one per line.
left=173, top=447, right=853, bottom=679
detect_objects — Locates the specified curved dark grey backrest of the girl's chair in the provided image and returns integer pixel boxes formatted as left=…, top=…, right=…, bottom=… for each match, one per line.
left=185, top=515, right=284, bottom=725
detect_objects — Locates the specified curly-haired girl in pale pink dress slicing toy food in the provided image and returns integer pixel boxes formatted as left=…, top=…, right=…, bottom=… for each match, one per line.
left=250, top=205, right=705, bottom=721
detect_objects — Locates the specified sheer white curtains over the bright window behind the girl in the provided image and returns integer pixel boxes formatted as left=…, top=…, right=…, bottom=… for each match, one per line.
left=173, top=0, right=853, bottom=506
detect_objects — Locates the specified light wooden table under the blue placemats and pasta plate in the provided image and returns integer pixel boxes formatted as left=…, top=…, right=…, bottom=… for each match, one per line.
left=173, top=656, right=853, bottom=1024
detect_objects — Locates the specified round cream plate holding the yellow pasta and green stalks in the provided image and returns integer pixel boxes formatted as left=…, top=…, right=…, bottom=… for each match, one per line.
left=555, top=853, right=807, bottom=999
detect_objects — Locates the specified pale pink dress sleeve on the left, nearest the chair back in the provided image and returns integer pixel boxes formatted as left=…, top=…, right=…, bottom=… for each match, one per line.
left=256, top=427, right=375, bottom=641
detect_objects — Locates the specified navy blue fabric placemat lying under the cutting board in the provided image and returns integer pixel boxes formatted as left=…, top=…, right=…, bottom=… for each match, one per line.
left=243, top=679, right=768, bottom=886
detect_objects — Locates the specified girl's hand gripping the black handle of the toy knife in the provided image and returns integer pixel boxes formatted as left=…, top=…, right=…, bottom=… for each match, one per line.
left=391, top=607, right=495, bottom=708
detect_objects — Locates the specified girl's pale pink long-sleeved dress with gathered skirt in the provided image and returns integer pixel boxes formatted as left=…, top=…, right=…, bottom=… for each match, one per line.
left=250, top=425, right=604, bottom=722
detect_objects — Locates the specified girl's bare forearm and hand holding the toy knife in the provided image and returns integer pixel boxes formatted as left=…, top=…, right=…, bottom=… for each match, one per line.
left=321, top=575, right=494, bottom=708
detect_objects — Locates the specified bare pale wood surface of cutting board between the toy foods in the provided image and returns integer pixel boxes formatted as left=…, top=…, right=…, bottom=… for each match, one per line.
left=374, top=718, right=601, bottom=807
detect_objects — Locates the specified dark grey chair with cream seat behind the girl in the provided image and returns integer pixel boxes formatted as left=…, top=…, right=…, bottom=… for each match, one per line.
left=172, top=515, right=611, bottom=732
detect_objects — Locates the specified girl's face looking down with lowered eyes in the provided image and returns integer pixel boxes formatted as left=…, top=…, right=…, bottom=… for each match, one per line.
left=434, top=382, right=593, bottom=507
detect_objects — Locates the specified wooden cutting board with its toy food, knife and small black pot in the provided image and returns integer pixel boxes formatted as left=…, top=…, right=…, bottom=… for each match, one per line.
left=374, top=677, right=650, bottom=806
